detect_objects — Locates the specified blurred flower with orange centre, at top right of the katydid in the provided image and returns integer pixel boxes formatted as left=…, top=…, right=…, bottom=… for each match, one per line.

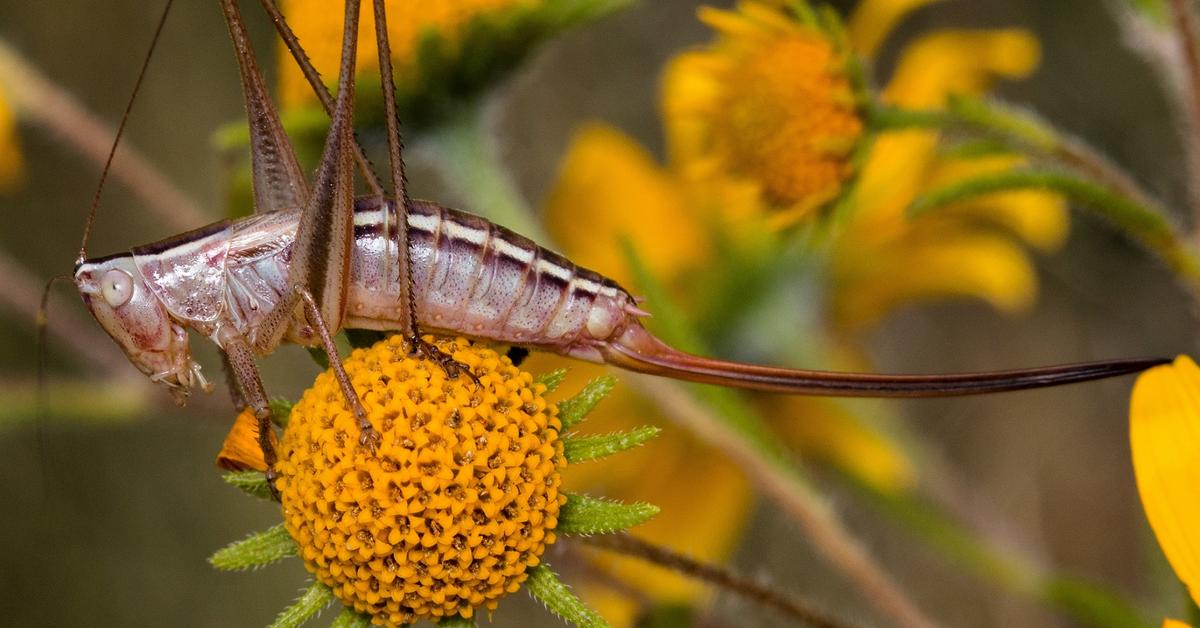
left=662, top=1, right=863, bottom=225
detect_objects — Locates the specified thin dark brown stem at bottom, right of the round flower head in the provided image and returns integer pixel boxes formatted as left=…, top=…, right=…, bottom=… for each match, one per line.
left=581, top=533, right=847, bottom=628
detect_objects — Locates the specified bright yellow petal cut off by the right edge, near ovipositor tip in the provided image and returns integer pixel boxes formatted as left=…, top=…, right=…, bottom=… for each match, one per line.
left=1129, top=355, right=1200, bottom=604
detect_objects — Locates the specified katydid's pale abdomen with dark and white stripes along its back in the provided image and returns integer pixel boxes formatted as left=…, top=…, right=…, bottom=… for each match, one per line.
left=346, top=198, right=640, bottom=360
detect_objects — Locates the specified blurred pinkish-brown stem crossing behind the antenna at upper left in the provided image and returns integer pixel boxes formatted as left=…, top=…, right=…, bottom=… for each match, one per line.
left=0, top=38, right=210, bottom=231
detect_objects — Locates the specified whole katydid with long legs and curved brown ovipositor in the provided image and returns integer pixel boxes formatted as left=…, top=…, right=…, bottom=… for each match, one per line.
left=65, top=0, right=1166, bottom=492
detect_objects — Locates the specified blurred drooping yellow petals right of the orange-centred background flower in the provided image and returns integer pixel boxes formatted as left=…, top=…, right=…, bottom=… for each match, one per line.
left=829, top=25, right=1068, bottom=330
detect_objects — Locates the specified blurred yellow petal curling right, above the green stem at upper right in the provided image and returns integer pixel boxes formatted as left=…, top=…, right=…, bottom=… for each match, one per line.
left=883, top=29, right=1040, bottom=108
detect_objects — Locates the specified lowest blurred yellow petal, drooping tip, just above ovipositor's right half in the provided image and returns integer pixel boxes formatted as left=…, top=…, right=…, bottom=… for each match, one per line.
left=832, top=232, right=1037, bottom=329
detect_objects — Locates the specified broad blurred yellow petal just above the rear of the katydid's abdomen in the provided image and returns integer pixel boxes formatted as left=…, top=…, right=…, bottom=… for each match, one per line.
left=545, top=124, right=707, bottom=283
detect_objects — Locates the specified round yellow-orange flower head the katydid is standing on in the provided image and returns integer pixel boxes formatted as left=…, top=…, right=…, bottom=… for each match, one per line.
left=276, top=336, right=565, bottom=626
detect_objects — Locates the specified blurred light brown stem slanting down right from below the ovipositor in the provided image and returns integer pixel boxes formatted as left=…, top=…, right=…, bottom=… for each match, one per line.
left=622, top=373, right=934, bottom=628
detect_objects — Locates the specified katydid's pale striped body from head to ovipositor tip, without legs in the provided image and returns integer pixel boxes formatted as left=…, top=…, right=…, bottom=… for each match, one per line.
left=76, top=197, right=1169, bottom=397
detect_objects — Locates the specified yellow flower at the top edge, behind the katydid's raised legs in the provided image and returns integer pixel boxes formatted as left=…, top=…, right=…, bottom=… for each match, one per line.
left=280, top=0, right=540, bottom=109
